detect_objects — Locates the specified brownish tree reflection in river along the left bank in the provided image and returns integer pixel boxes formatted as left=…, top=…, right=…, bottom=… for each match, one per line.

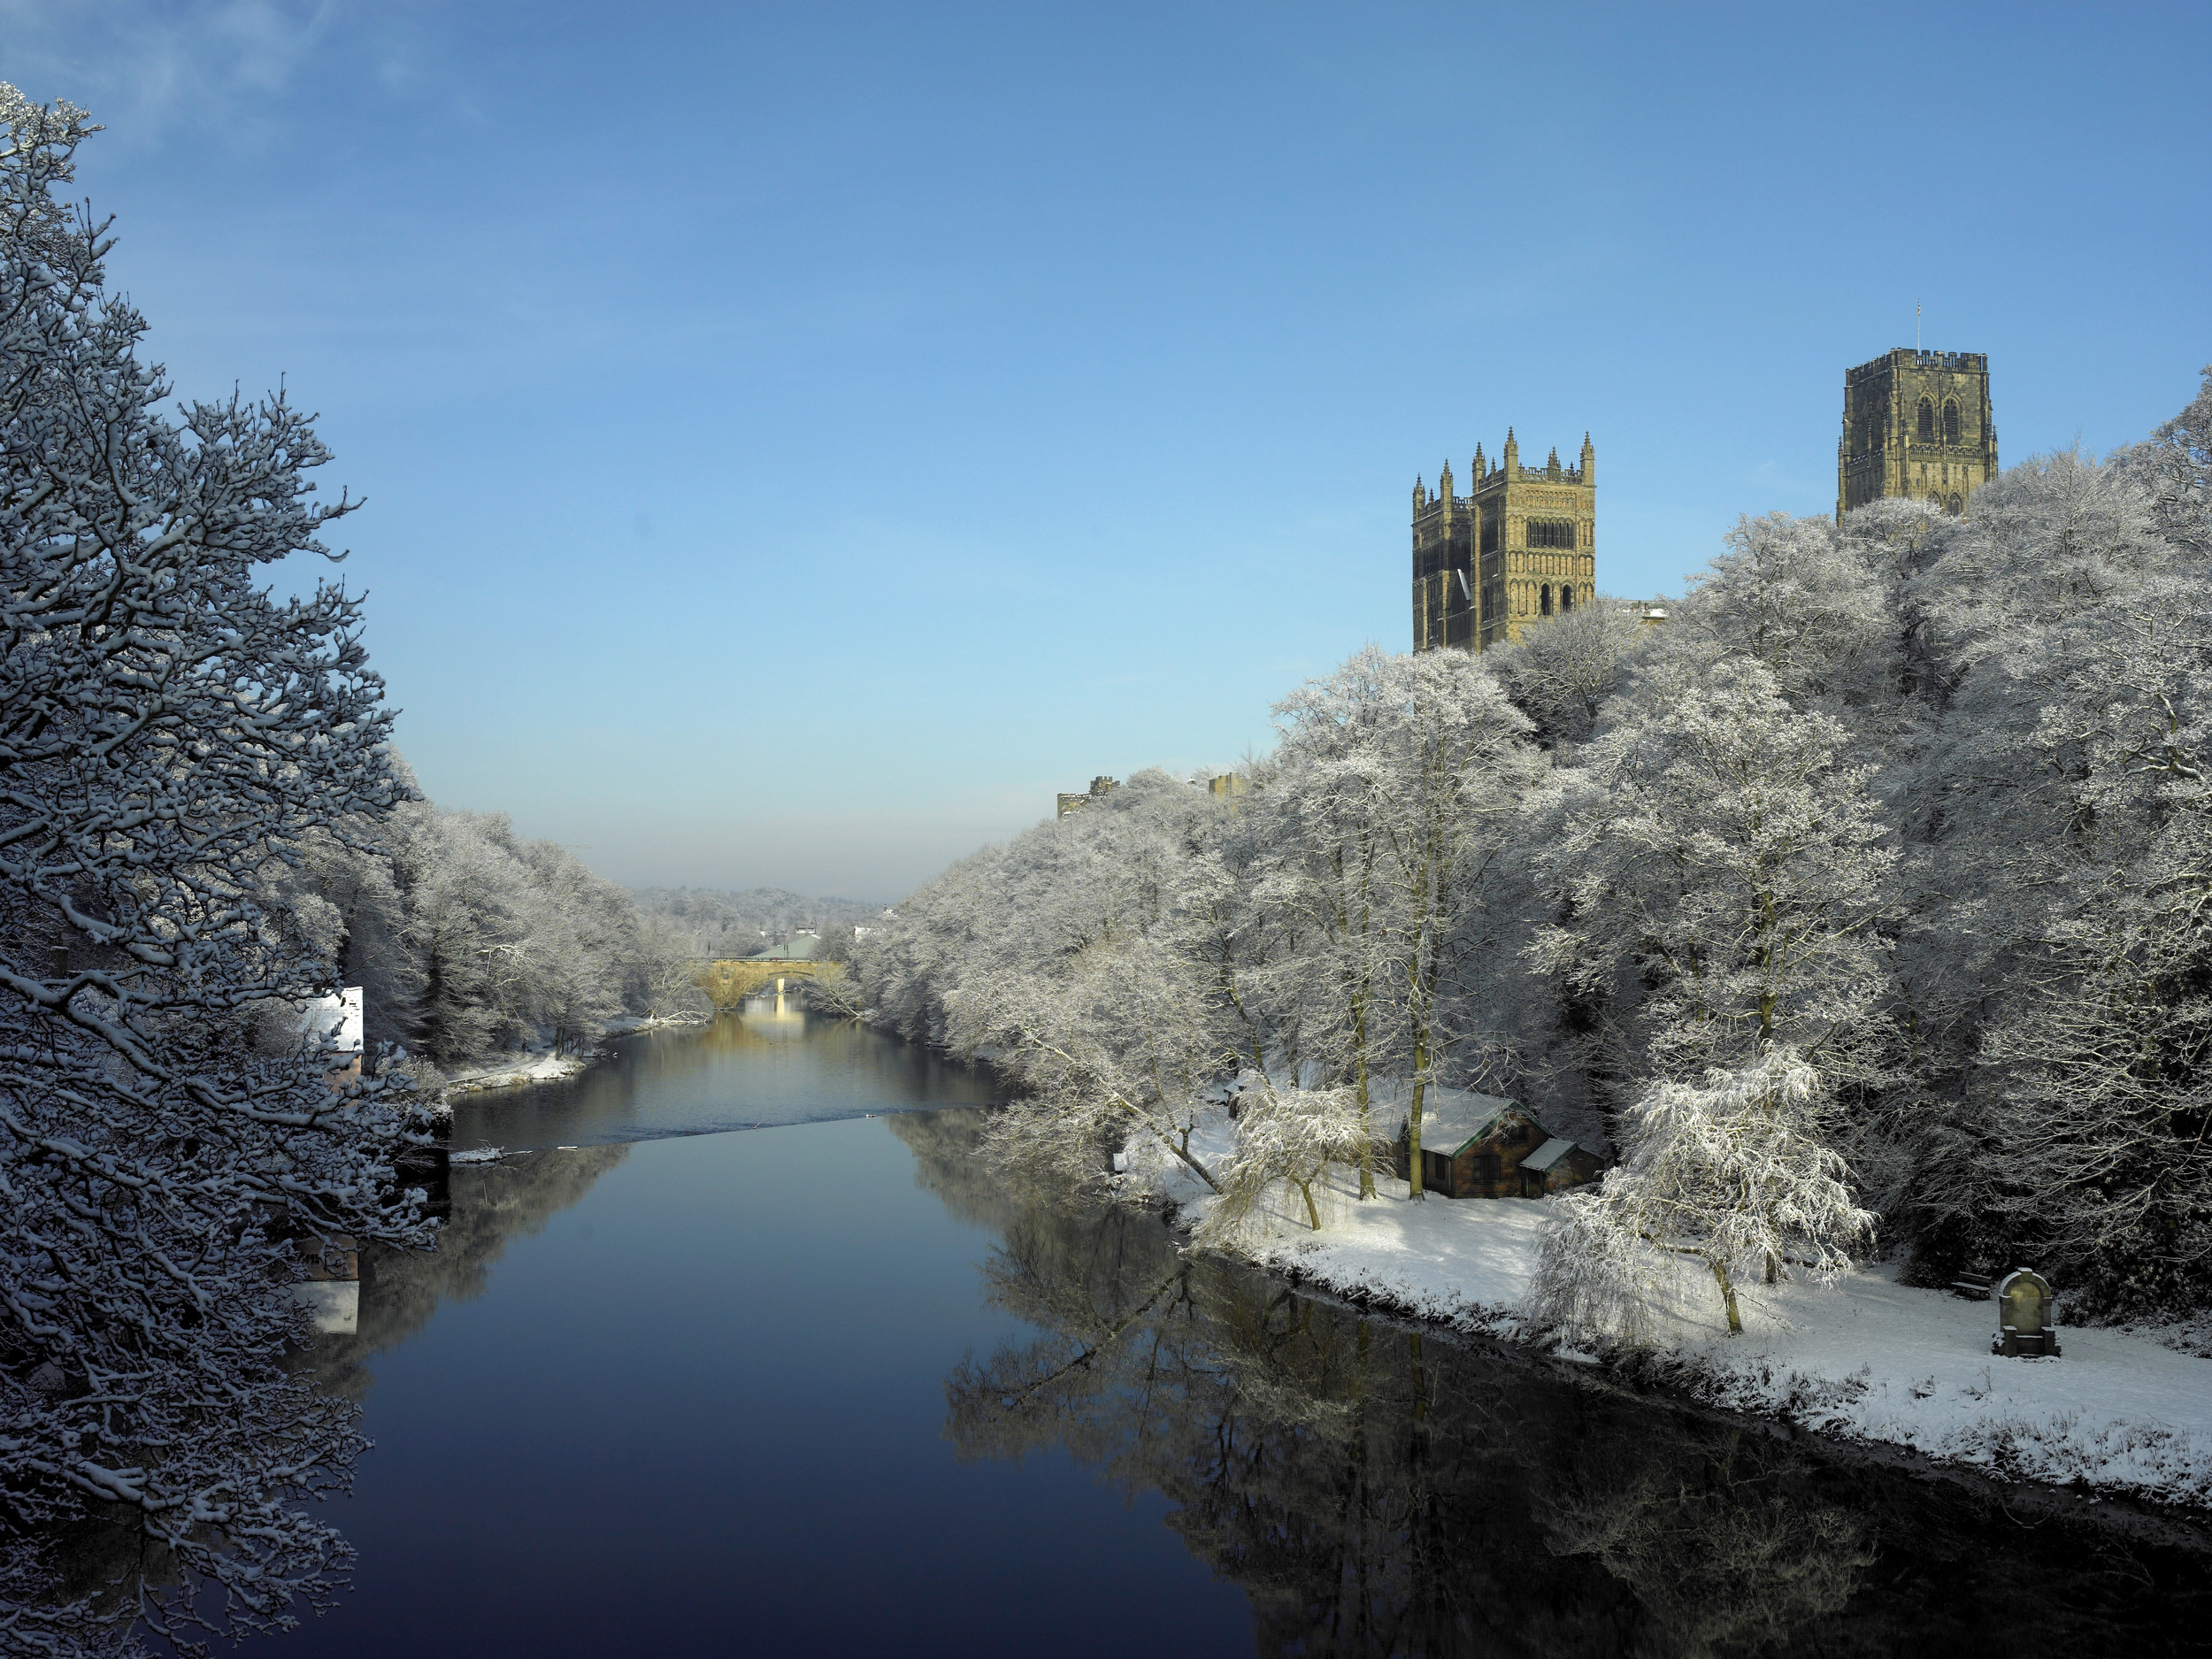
left=308, top=1144, right=631, bottom=1401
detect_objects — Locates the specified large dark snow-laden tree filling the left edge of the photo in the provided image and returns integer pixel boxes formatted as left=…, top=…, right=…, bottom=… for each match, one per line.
left=0, top=88, right=425, bottom=1653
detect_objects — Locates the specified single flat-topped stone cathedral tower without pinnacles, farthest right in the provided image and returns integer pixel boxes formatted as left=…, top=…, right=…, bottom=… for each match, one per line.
left=1836, top=348, right=1998, bottom=525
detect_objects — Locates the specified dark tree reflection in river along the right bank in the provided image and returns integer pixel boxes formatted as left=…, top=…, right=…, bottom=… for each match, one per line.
left=898, top=1115, right=2212, bottom=1657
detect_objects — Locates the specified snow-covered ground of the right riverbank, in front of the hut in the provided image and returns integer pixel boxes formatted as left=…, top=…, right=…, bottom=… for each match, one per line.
left=1122, top=1097, right=2212, bottom=1507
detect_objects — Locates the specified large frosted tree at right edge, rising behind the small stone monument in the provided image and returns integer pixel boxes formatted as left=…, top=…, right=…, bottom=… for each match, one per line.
left=1920, top=578, right=2212, bottom=1308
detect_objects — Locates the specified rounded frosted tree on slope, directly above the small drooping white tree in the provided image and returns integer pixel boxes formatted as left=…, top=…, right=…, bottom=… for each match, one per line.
left=1533, top=659, right=1898, bottom=1110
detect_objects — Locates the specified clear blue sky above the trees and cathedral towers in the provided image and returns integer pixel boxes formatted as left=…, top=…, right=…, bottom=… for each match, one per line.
left=0, top=0, right=2212, bottom=898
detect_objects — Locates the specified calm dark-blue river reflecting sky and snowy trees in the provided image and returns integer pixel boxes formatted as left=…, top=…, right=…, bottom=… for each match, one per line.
left=255, top=1018, right=2212, bottom=1659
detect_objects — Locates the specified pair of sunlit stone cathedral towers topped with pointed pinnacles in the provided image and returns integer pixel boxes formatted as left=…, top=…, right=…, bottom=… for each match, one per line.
left=1414, top=427, right=1597, bottom=650
